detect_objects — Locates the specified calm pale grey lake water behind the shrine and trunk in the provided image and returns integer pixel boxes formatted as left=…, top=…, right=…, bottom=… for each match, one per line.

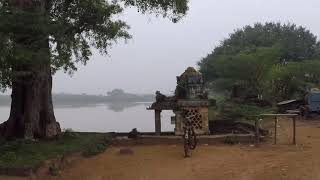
left=0, top=103, right=174, bottom=132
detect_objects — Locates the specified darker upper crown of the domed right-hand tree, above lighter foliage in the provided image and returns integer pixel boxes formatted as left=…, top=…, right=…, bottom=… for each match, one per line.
left=199, top=23, right=320, bottom=80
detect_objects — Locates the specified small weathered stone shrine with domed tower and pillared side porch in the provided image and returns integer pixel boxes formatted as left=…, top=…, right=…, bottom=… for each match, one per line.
left=148, top=67, right=210, bottom=135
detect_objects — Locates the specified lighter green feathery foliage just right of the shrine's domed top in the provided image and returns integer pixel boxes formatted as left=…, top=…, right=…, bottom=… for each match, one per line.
left=214, top=47, right=279, bottom=92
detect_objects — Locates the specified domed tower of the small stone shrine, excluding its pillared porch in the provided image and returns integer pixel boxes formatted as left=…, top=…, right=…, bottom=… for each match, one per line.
left=173, top=67, right=210, bottom=135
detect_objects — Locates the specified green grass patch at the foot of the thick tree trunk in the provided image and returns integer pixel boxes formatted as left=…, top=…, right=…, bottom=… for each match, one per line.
left=0, top=131, right=111, bottom=167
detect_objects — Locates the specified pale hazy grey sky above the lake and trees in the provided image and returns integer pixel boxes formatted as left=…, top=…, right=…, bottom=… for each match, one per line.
left=35, top=0, right=320, bottom=94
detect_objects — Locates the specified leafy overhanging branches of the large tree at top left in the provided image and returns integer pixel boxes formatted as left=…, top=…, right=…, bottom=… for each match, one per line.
left=0, top=0, right=188, bottom=90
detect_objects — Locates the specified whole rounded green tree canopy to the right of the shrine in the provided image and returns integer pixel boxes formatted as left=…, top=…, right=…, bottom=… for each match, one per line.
left=199, top=23, right=320, bottom=101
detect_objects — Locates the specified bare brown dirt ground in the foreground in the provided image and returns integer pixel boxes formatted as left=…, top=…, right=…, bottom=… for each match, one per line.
left=0, top=121, right=320, bottom=180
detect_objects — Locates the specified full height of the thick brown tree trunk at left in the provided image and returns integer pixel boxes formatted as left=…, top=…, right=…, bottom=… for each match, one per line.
left=0, top=0, right=61, bottom=138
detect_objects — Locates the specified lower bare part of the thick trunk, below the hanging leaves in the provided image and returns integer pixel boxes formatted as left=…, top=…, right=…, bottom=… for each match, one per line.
left=1, top=66, right=61, bottom=138
